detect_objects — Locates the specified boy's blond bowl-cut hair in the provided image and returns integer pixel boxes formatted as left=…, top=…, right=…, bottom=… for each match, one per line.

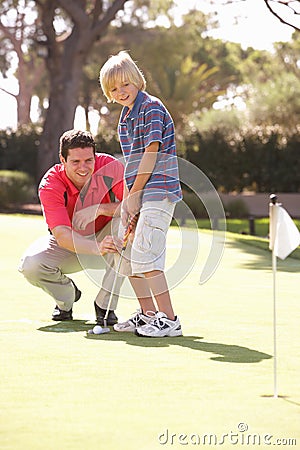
left=99, top=50, right=146, bottom=103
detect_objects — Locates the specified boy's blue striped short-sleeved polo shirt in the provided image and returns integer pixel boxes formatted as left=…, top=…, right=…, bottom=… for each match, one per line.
left=118, top=91, right=182, bottom=202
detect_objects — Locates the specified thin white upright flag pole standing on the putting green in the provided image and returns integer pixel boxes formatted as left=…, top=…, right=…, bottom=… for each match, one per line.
left=270, top=194, right=279, bottom=398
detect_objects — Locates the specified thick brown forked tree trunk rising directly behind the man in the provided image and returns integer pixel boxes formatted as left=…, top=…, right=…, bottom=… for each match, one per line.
left=36, top=0, right=132, bottom=177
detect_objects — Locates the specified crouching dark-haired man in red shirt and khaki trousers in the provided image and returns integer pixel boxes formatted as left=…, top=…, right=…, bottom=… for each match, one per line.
left=19, top=130, right=124, bottom=325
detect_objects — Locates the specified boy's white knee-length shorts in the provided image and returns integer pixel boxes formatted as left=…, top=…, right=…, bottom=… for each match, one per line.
left=131, top=199, right=175, bottom=276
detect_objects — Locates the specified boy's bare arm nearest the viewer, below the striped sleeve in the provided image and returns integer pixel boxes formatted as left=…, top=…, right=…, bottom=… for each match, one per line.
left=126, top=141, right=159, bottom=217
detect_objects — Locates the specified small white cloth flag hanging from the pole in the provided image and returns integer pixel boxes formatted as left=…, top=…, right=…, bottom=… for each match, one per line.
left=269, top=203, right=300, bottom=259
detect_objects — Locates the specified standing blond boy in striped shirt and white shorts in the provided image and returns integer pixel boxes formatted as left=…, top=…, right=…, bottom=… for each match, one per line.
left=100, top=51, right=182, bottom=337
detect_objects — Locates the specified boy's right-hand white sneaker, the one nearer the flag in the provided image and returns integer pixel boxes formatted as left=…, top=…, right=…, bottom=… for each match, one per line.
left=135, top=312, right=182, bottom=337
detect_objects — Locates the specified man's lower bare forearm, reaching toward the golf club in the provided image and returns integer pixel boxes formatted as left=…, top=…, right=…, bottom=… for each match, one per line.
left=51, top=225, right=122, bottom=256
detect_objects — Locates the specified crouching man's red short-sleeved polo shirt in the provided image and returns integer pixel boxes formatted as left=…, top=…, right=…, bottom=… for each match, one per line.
left=39, top=153, right=124, bottom=236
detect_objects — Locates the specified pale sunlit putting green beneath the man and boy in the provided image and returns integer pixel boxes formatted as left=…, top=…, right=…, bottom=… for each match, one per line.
left=0, top=215, right=300, bottom=450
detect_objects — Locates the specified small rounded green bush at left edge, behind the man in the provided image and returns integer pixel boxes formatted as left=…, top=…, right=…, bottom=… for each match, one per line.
left=0, top=170, right=36, bottom=208
